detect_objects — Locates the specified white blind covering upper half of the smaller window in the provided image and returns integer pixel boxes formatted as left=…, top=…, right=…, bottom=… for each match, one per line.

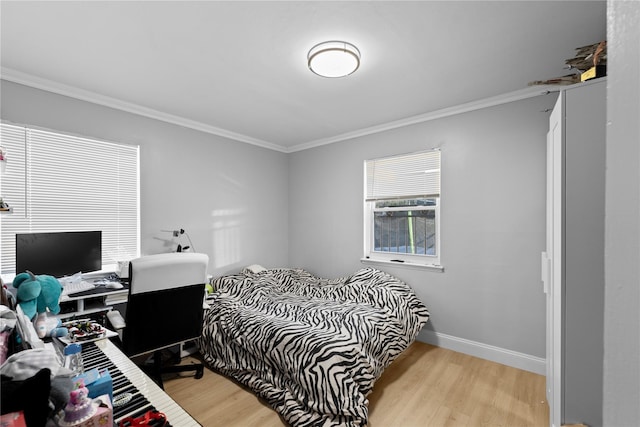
left=365, top=150, right=440, bottom=201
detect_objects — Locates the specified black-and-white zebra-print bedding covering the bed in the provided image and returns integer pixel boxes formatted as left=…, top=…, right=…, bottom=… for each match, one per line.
left=198, top=268, right=429, bottom=426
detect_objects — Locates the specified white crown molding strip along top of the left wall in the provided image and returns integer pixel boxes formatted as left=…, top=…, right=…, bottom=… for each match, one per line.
left=0, top=67, right=287, bottom=153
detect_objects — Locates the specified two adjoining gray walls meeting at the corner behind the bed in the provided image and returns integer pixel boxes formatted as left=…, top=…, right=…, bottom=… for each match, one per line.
left=1, top=81, right=555, bottom=372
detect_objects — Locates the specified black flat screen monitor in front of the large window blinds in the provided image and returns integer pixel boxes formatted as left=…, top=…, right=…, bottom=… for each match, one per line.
left=16, top=231, right=102, bottom=277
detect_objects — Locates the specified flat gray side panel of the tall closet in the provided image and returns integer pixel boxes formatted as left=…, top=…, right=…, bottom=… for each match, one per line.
left=562, top=80, right=607, bottom=427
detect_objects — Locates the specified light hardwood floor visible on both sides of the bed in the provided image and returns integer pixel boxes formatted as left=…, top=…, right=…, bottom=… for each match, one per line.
left=165, top=342, right=549, bottom=427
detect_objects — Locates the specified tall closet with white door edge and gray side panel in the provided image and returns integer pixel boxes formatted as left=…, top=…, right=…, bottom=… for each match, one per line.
left=542, top=79, right=606, bottom=427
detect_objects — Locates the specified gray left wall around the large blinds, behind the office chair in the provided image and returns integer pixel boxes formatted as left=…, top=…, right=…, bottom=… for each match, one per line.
left=0, top=80, right=288, bottom=275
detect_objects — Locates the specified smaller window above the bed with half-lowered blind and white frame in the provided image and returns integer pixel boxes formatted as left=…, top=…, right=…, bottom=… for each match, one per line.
left=364, top=150, right=440, bottom=268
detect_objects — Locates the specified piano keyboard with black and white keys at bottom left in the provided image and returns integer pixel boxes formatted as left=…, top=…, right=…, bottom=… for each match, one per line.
left=82, top=339, right=201, bottom=427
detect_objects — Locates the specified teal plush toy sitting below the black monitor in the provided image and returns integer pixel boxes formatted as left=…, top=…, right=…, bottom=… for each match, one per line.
left=13, top=271, right=62, bottom=320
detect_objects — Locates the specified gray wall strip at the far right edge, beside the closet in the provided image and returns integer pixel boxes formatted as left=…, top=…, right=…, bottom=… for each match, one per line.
left=603, top=0, right=640, bottom=427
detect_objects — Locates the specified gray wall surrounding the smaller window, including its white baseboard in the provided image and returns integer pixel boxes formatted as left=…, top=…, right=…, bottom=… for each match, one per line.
left=289, top=94, right=557, bottom=373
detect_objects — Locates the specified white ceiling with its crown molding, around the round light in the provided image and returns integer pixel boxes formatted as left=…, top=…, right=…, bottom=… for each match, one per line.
left=0, top=0, right=606, bottom=152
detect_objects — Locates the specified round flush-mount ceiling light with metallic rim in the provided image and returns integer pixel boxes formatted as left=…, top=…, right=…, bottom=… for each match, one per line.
left=307, top=41, right=360, bottom=78
